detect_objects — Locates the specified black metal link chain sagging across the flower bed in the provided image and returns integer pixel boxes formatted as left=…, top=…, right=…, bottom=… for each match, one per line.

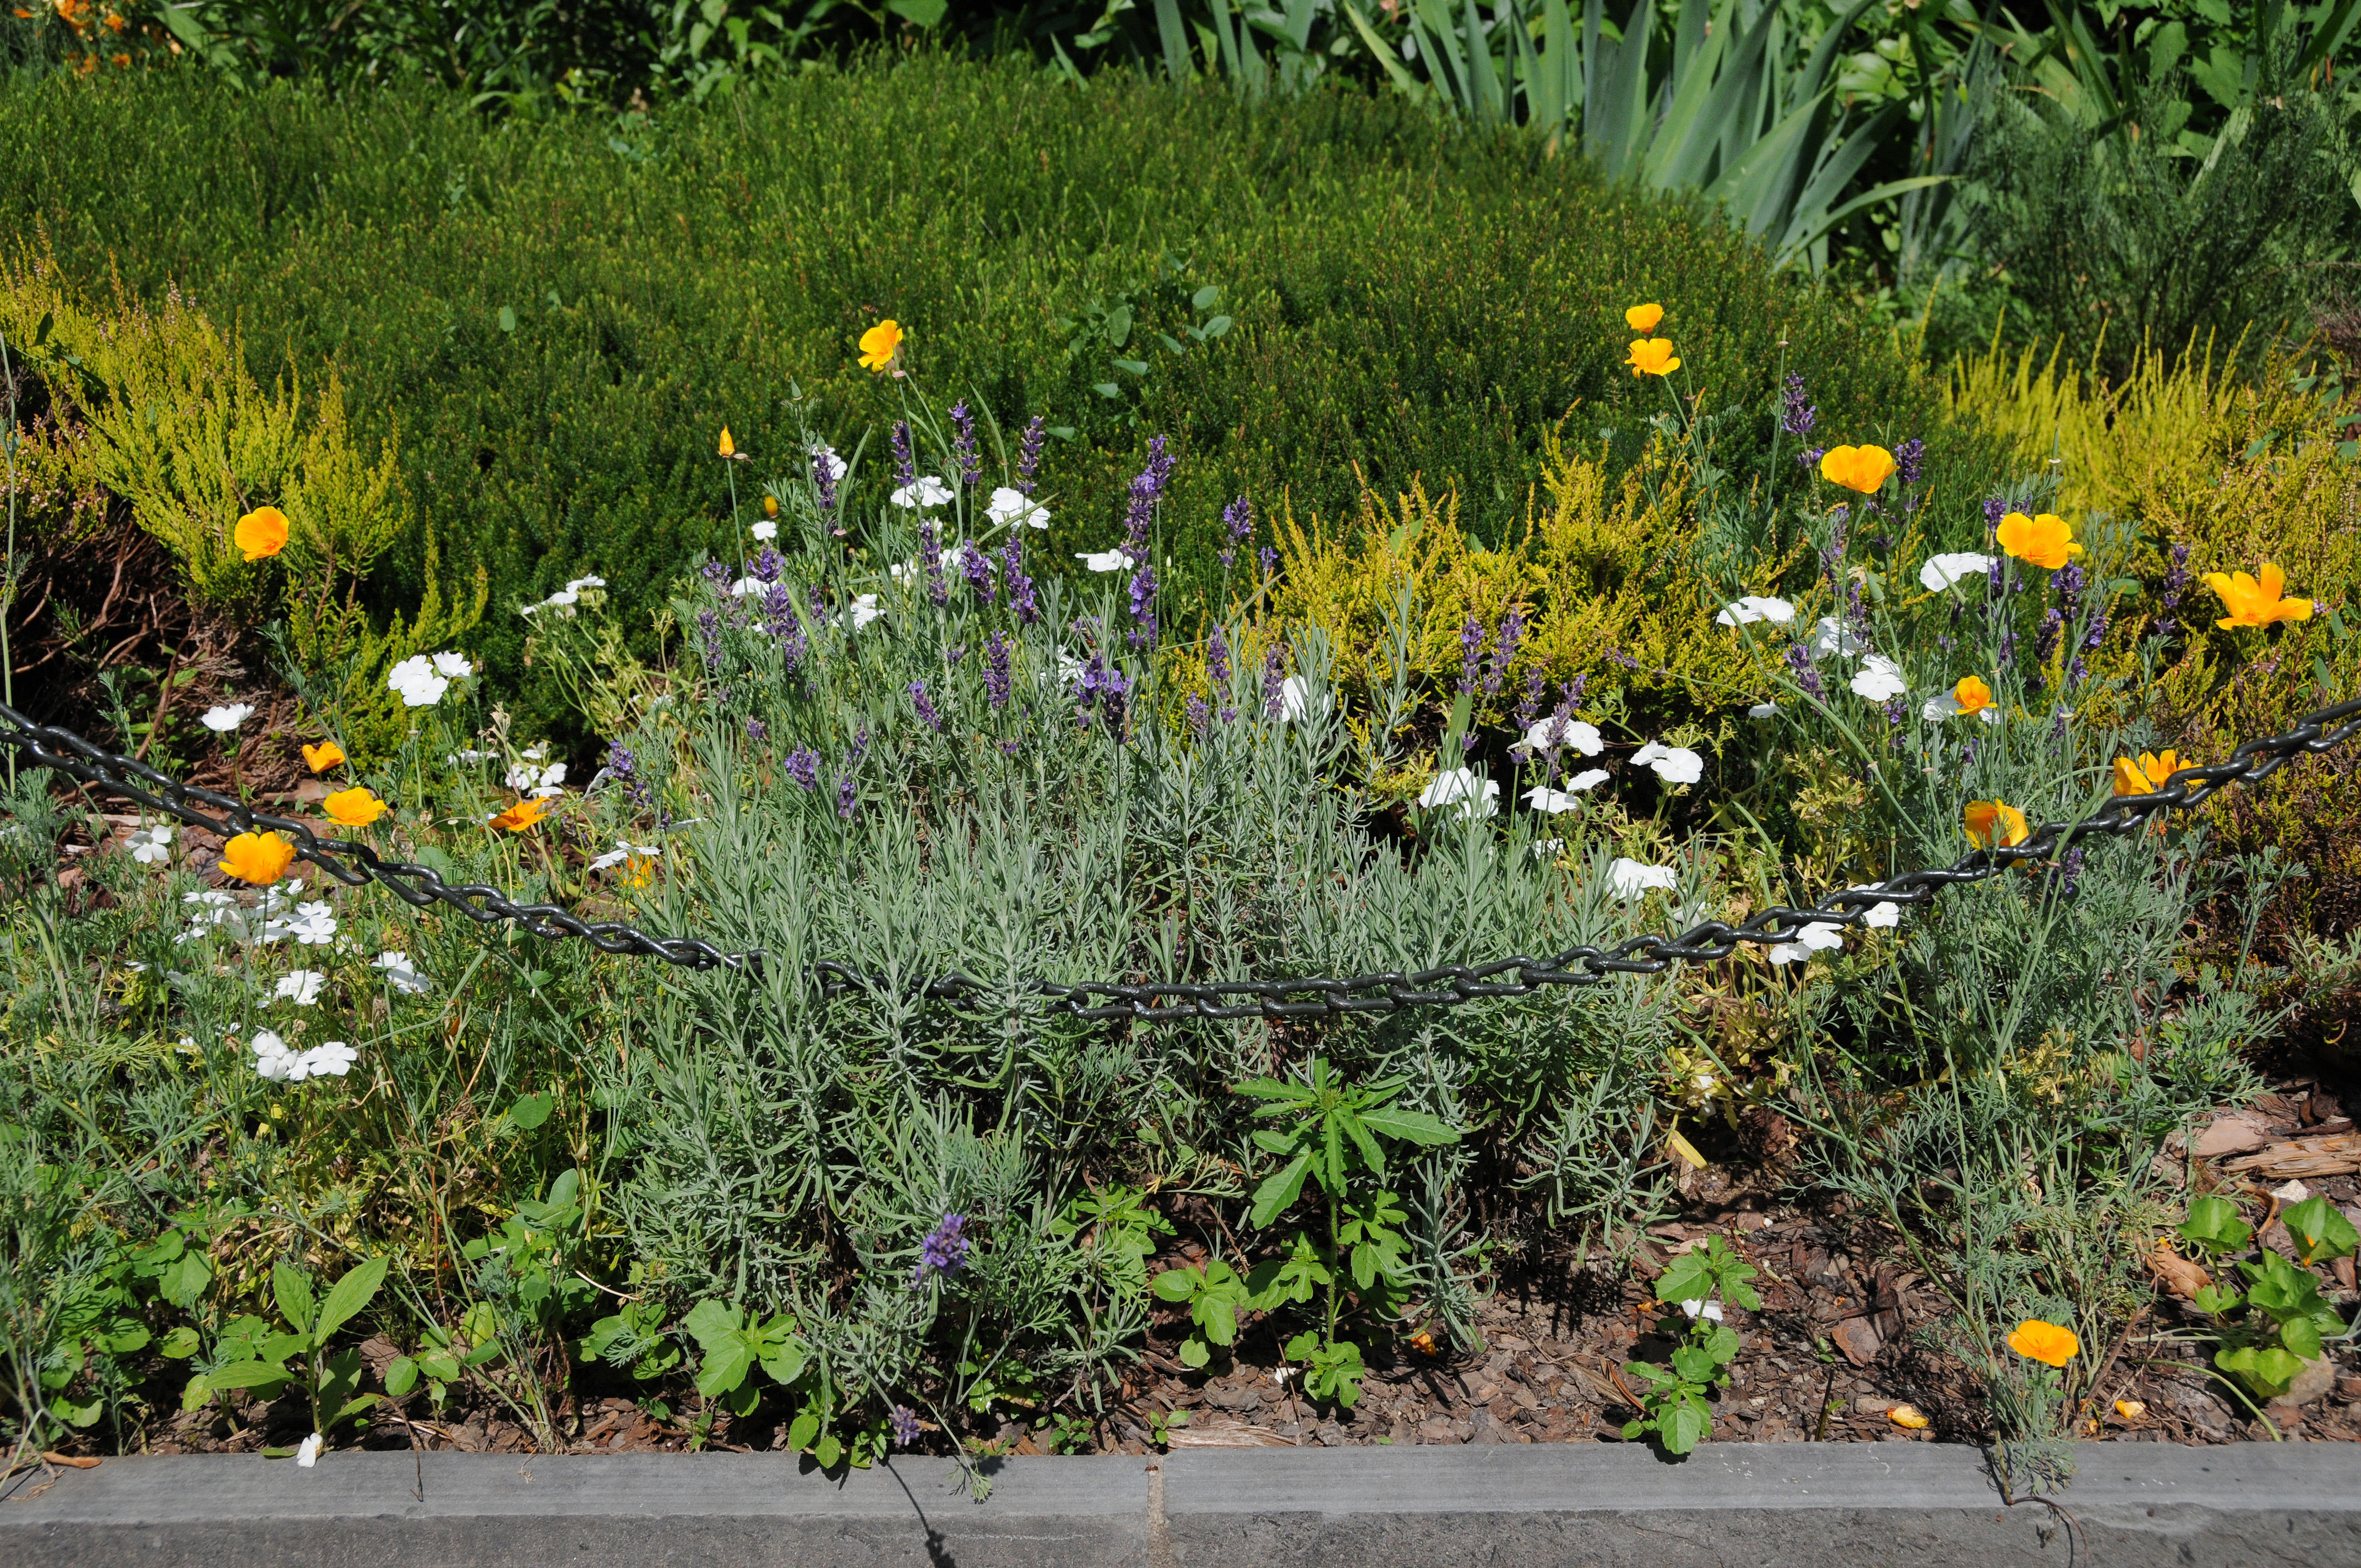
left=0, top=696, right=2361, bottom=1022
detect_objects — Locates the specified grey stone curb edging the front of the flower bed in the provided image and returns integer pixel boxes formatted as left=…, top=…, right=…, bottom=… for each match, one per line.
left=0, top=1443, right=2361, bottom=1568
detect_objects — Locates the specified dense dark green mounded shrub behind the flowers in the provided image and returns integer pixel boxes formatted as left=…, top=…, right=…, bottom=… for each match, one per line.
left=0, top=57, right=1983, bottom=727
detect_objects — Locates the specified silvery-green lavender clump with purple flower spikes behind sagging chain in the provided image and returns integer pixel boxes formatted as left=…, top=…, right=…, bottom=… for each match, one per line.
left=609, top=399, right=1669, bottom=1398
